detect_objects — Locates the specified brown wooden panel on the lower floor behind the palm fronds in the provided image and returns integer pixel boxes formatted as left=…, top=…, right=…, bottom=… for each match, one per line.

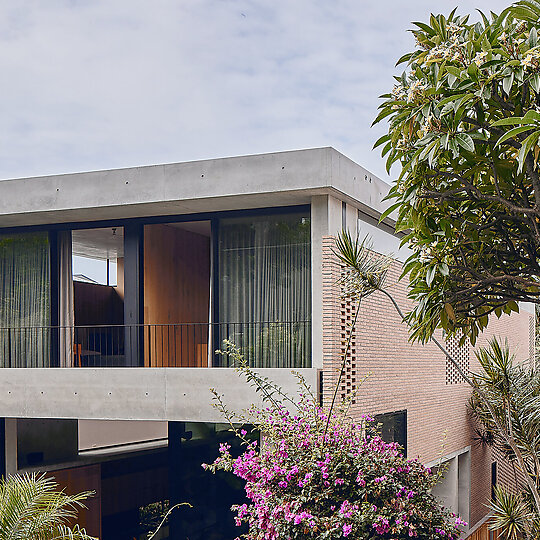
left=49, top=463, right=101, bottom=538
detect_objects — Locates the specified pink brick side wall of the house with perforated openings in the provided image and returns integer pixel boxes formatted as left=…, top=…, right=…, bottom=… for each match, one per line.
left=323, top=236, right=531, bottom=525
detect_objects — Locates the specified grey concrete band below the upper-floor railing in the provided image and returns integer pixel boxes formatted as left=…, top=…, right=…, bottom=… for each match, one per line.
left=0, top=368, right=316, bottom=422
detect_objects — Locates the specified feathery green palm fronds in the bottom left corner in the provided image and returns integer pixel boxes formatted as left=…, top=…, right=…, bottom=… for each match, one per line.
left=0, top=473, right=93, bottom=540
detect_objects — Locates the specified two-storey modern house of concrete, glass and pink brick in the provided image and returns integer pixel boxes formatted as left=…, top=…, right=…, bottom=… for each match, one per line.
left=0, top=148, right=532, bottom=540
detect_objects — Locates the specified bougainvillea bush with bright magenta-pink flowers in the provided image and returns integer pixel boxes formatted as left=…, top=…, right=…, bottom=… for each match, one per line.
left=203, top=356, right=464, bottom=540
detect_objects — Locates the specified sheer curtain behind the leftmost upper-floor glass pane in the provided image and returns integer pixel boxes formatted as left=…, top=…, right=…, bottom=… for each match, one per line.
left=0, top=232, right=50, bottom=367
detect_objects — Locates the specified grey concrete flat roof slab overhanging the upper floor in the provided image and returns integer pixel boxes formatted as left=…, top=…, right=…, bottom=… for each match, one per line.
left=0, top=147, right=389, bottom=228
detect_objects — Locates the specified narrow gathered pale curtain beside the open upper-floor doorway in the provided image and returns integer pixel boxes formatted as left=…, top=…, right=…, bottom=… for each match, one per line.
left=58, top=231, right=75, bottom=367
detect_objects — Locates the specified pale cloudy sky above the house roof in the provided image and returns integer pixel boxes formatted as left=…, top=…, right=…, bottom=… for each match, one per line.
left=0, top=0, right=508, bottom=184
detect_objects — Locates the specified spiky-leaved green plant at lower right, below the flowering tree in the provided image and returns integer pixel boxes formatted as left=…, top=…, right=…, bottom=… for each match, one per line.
left=469, top=340, right=540, bottom=539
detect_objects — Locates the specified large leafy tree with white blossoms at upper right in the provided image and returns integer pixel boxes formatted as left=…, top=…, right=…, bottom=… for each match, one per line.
left=375, top=0, right=540, bottom=343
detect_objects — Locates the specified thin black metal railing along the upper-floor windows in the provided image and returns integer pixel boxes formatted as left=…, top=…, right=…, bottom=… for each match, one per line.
left=0, top=321, right=311, bottom=368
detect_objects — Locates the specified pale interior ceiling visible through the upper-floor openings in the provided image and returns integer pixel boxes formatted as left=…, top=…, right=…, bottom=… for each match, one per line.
left=72, top=221, right=210, bottom=260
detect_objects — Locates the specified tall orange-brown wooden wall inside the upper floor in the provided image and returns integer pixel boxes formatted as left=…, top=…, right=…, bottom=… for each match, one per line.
left=144, top=225, right=210, bottom=367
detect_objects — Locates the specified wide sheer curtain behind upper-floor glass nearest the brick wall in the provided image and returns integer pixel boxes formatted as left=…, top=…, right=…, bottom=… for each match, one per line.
left=219, top=214, right=311, bottom=367
